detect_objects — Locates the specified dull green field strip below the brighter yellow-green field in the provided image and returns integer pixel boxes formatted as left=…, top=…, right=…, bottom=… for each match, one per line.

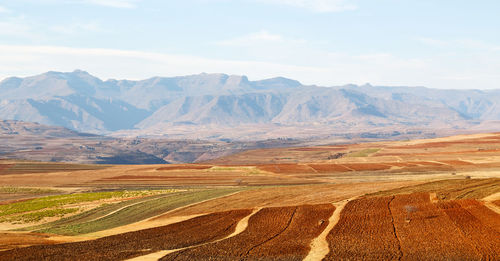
left=29, top=188, right=241, bottom=235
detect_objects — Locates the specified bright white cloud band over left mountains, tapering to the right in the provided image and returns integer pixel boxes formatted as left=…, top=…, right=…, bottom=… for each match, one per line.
left=0, top=45, right=327, bottom=82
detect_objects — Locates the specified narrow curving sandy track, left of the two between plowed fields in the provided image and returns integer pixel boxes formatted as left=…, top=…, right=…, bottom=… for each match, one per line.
left=126, top=207, right=262, bottom=261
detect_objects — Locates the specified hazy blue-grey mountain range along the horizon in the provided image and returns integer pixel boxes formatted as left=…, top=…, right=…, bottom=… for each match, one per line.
left=0, top=70, right=500, bottom=138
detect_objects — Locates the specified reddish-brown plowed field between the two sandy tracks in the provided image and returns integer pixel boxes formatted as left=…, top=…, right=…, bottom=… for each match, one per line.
left=161, top=204, right=335, bottom=260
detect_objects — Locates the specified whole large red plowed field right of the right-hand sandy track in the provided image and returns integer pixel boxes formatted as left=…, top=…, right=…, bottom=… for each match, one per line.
left=326, top=193, right=500, bottom=260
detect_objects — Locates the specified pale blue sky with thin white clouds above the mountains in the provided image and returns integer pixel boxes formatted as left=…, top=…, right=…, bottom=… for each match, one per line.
left=0, top=0, right=500, bottom=89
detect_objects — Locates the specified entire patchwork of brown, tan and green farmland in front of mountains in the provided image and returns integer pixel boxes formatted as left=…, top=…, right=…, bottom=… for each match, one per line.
left=0, top=133, right=500, bottom=260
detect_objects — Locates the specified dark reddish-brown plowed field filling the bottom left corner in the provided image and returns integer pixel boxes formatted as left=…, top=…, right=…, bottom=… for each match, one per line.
left=0, top=210, right=252, bottom=260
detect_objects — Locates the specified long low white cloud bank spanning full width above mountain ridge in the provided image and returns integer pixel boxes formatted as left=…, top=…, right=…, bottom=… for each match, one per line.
left=0, top=45, right=500, bottom=89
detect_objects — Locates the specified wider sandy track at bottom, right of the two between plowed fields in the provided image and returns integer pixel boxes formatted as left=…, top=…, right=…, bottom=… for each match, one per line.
left=304, top=196, right=357, bottom=261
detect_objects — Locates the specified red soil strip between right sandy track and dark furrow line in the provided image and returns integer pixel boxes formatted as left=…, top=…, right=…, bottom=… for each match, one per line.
left=324, top=197, right=401, bottom=260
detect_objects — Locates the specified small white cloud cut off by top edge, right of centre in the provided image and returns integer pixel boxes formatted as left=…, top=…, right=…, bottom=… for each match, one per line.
left=257, top=0, right=357, bottom=13
